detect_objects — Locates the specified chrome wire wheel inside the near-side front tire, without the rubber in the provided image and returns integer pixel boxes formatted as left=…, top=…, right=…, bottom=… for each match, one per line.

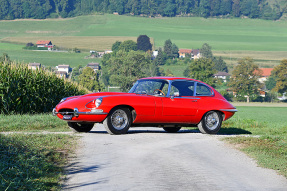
left=111, top=109, right=128, bottom=130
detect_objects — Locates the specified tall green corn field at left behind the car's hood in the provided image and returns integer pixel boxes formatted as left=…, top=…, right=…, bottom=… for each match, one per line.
left=0, top=62, right=88, bottom=114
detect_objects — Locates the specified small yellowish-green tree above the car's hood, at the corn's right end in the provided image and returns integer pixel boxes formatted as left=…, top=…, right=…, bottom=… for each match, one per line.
left=79, top=67, right=103, bottom=91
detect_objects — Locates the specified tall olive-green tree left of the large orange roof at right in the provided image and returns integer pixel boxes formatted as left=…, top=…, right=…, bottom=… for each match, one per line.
left=228, top=57, right=262, bottom=102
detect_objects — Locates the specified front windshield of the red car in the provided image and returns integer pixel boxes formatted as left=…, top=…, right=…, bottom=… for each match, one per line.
left=129, top=80, right=168, bottom=96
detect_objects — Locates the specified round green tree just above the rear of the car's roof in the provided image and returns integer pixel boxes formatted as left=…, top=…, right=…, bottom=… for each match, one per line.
left=186, top=58, right=216, bottom=87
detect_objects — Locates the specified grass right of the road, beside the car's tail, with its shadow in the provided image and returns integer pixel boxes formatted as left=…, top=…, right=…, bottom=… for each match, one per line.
left=222, top=106, right=287, bottom=177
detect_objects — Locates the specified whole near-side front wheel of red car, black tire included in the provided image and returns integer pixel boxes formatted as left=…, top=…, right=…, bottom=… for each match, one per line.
left=103, top=107, right=132, bottom=135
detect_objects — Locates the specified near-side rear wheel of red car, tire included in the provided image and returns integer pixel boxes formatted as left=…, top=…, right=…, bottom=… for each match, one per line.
left=198, top=111, right=222, bottom=134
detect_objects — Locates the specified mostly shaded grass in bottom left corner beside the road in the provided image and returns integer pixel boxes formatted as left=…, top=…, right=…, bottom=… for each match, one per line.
left=0, top=134, right=75, bottom=190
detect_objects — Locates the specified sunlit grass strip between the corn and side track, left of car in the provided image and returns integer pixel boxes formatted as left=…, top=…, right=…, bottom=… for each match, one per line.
left=0, top=114, right=69, bottom=132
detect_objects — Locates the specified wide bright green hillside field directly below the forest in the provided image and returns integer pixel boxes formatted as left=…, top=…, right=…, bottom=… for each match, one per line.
left=0, top=15, right=287, bottom=51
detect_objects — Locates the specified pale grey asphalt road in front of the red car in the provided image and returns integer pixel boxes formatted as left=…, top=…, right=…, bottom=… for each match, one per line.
left=63, top=125, right=287, bottom=191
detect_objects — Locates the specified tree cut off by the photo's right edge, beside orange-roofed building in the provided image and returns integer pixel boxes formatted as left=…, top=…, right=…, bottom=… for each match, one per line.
left=272, top=59, right=287, bottom=93
